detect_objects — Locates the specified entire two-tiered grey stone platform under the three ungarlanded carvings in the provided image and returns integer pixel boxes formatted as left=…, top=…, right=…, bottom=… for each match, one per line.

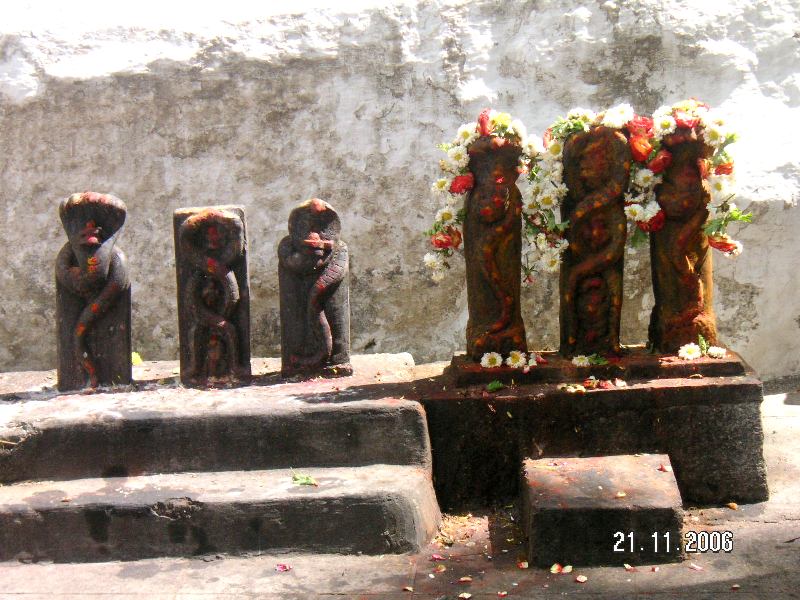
left=0, top=354, right=440, bottom=561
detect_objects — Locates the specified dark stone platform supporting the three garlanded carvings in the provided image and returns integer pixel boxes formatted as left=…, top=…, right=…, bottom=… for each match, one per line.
left=413, top=350, right=768, bottom=510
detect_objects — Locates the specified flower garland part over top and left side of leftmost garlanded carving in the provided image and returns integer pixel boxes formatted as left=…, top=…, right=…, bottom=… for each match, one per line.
left=423, top=108, right=531, bottom=282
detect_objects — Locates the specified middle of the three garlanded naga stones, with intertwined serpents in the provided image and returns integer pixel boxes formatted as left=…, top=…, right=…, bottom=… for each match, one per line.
left=560, top=127, right=631, bottom=356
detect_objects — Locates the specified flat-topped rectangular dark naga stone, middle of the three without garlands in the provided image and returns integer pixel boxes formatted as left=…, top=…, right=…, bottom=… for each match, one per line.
left=173, top=206, right=250, bottom=386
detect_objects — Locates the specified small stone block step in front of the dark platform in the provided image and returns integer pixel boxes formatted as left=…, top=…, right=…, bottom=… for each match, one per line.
left=522, top=454, right=683, bottom=567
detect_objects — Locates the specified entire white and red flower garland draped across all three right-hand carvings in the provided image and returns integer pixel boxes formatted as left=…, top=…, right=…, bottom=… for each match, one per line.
left=423, top=99, right=752, bottom=285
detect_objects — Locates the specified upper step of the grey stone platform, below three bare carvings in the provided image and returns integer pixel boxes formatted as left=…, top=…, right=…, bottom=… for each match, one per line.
left=0, top=386, right=431, bottom=483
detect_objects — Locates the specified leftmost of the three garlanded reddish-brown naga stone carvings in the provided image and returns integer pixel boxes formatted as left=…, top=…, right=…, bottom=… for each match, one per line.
left=464, top=136, right=527, bottom=361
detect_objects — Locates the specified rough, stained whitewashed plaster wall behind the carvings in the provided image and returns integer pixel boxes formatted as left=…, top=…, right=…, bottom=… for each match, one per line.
left=0, top=0, right=800, bottom=378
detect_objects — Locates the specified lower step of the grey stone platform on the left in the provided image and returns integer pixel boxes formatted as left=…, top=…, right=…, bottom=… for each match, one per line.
left=0, top=465, right=440, bottom=562
